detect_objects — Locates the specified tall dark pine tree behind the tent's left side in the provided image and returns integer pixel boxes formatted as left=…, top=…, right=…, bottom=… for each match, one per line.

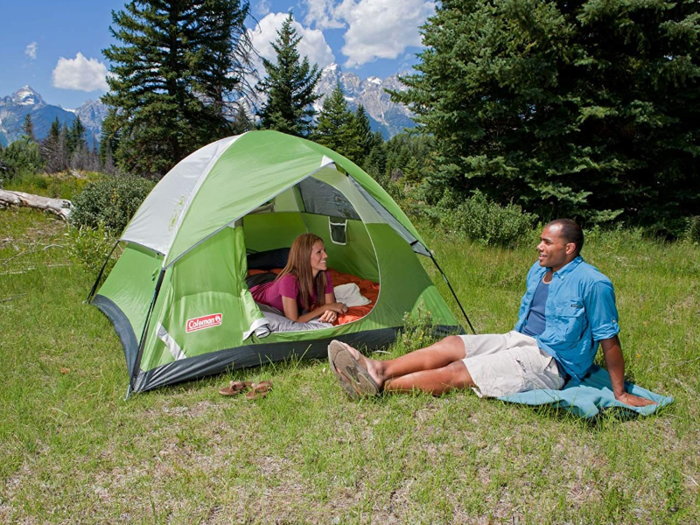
left=102, top=0, right=249, bottom=174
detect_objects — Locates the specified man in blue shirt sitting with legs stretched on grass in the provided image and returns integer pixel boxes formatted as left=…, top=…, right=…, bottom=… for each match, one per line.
left=328, top=219, right=653, bottom=407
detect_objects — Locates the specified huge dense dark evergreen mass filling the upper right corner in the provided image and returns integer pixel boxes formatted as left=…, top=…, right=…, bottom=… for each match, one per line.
left=392, top=0, right=700, bottom=227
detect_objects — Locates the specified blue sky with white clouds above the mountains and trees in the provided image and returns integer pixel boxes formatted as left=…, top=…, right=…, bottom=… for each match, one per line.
left=0, top=0, right=435, bottom=108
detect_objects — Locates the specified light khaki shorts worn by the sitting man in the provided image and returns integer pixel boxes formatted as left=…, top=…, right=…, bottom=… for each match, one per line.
left=460, top=331, right=564, bottom=397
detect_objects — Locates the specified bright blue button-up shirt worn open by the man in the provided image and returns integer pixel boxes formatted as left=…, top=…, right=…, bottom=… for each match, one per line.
left=515, top=256, right=620, bottom=380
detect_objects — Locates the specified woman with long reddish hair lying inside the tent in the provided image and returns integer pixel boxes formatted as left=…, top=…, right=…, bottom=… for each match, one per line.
left=250, top=233, right=348, bottom=323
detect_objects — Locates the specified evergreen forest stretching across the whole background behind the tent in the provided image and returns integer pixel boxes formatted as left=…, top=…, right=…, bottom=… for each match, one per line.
left=0, top=0, right=700, bottom=237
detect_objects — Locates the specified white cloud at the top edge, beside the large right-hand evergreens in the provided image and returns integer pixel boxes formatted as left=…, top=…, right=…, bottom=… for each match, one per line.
left=337, top=0, right=435, bottom=67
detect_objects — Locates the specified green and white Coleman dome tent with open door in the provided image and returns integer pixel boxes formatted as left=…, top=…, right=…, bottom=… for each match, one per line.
left=89, top=131, right=468, bottom=392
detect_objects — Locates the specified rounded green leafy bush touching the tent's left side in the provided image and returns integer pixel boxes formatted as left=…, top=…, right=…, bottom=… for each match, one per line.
left=70, top=177, right=153, bottom=235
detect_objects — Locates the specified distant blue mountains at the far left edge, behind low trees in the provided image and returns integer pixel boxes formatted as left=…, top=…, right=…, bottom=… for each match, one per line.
left=0, top=86, right=107, bottom=147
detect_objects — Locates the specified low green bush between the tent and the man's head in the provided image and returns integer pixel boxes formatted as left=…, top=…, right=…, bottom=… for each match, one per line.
left=430, top=192, right=537, bottom=246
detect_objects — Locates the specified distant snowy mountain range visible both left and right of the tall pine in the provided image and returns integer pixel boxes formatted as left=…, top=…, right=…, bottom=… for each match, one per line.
left=0, top=64, right=415, bottom=147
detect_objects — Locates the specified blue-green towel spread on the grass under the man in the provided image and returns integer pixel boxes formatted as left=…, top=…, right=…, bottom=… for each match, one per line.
left=498, top=365, right=673, bottom=418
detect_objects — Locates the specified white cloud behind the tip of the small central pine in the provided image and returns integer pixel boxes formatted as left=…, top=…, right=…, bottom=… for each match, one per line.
left=249, top=13, right=335, bottom=69
